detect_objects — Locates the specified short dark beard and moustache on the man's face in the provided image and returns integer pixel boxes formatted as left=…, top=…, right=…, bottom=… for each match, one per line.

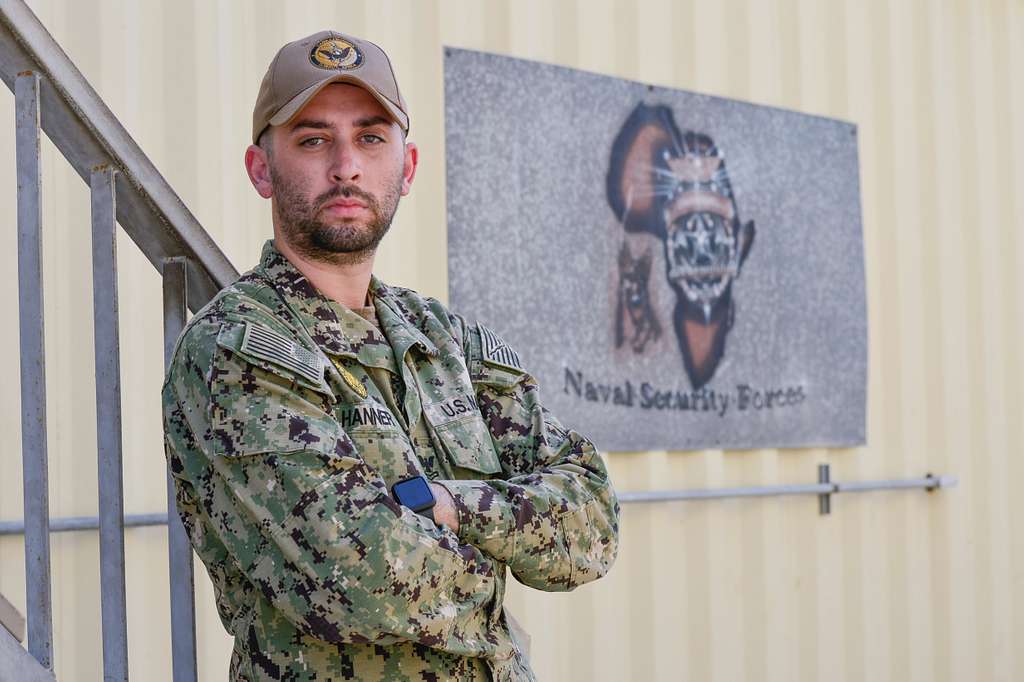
left=270, top=164, right=401, bottom=265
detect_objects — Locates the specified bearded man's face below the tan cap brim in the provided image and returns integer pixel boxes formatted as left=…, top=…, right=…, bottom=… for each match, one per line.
left=257, top=84, right=416, bottom=263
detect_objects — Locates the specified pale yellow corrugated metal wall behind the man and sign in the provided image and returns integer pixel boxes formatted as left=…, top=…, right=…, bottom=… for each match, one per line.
left=0, top=0, right=1024, bottom=682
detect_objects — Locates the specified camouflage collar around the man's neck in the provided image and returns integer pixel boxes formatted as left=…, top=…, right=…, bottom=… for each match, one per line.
left=256, top=240, right=437, bottom=366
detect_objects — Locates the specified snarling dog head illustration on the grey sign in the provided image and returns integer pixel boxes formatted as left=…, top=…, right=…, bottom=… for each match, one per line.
left=607, top=102, right=755, bottom=389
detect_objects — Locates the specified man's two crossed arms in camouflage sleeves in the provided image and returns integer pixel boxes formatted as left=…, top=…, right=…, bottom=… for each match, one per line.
left=164, top=311, right=617, bottom=658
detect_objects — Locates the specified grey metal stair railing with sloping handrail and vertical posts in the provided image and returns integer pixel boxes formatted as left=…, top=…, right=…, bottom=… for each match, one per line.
left=0, top=0, right=238, bottom=682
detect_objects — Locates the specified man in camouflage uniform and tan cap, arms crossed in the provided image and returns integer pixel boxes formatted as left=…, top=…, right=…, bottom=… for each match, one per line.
left=163, top=32, right=618, bottom=681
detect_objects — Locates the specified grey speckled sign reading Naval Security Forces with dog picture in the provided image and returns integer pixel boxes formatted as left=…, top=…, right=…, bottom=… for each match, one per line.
left=444, top=49, right=867, bottom=451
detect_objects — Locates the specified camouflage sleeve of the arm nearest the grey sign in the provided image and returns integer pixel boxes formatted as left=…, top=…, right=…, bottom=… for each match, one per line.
left=439, top=315, right=618, bottom=591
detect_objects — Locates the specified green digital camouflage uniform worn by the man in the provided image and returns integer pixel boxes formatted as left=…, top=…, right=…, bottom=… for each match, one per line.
left=163, top=242, right=618, bottom=682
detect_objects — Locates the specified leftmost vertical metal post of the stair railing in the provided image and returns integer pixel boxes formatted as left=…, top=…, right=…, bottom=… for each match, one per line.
left=14, top=67, right=53, bottom=670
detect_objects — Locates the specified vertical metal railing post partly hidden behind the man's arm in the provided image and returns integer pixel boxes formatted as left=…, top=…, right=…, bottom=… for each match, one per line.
left=164, top=257, right=199, bottom=682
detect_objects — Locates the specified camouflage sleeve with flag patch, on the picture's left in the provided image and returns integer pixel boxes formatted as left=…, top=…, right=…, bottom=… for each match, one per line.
left=164, top=325, right=512, bottom=658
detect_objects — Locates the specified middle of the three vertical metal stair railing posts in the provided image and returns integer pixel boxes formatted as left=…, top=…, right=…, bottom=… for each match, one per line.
left=89, top=165, right=128, bottom=682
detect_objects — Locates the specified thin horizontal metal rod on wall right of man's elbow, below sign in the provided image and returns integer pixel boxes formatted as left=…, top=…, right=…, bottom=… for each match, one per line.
left=618, top=464, right=959, bottom=515
